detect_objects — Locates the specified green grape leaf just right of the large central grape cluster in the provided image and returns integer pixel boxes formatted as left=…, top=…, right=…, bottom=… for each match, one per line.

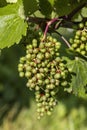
left=68, top=57, right=87, bottom=98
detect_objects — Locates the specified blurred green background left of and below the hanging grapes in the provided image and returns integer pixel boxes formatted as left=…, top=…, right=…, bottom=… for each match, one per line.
left=0, top=39, right=87, bottom=130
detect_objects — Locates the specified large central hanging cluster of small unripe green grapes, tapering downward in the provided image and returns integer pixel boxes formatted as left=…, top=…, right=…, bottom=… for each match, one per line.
left=18, top=36, right=68, bottom=119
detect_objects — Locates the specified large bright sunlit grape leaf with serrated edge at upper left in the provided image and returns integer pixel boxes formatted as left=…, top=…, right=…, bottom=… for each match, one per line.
left=0, top=0, right=27, bottom=49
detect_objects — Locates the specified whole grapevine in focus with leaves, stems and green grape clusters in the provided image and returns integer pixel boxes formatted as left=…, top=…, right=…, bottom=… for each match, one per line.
left=0, top=0, right=87, bottom=119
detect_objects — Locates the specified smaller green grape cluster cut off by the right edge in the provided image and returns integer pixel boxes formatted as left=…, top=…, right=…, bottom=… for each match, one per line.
left=70, top=22, right=87, bottom=56
